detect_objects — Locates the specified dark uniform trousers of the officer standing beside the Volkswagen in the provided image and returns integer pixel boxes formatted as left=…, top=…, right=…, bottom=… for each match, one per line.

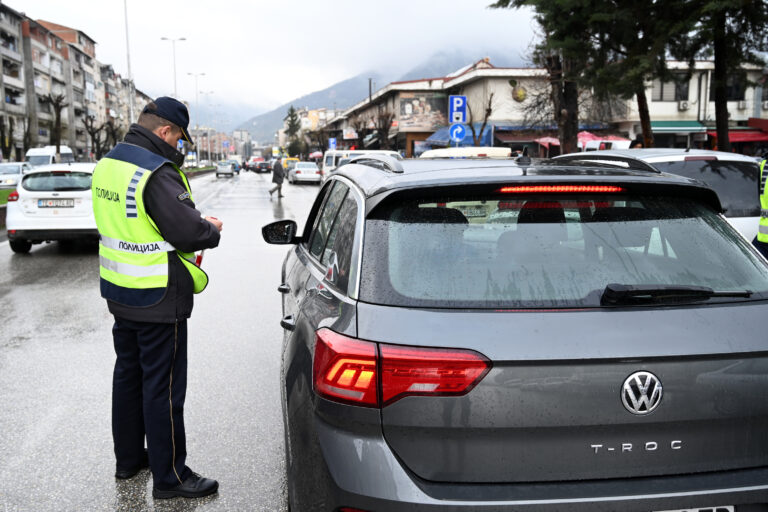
left=112, top=317, right=191, bottom=489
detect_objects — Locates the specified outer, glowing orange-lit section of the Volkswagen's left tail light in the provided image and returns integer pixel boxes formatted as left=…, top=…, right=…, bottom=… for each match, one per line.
left=312, top=329, right=379, bottom=407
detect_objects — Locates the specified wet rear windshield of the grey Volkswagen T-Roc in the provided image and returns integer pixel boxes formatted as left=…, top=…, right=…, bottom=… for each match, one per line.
left=360, top=195, right=768, bottom=308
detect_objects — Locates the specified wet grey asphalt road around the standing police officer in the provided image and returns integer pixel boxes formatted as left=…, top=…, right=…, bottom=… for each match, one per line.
left=0, top=173, right=319, bottom=512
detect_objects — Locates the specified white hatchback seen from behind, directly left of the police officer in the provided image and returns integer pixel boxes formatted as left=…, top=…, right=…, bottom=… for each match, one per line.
left=5, top=163, right=99, bottom=253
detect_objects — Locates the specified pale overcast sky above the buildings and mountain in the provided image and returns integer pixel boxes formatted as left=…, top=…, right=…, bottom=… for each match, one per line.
left=19, top=0, right=534, bottom=124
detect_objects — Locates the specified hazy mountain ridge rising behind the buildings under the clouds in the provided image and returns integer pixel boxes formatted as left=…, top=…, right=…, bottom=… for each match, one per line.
left=237, top=50, right=524, bottom=143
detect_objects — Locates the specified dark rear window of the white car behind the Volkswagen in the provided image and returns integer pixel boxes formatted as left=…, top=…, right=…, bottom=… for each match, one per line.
left=651, top=160, right=760, bottom=217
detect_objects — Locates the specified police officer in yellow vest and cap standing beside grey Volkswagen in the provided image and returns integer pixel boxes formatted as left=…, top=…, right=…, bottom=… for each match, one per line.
left=92, top=97, right=222, bottom=498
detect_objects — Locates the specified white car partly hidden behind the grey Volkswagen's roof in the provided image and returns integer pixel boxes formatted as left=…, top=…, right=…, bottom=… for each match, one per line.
left=554, top=148, right=760, bottom=241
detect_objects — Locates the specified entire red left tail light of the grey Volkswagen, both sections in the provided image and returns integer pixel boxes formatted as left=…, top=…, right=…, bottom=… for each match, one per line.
left=313, top=329, right=491, bottom=407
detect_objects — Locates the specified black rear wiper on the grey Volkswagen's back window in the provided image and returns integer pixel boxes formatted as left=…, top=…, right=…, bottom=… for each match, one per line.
left=600, top=283, right=753, bottom=306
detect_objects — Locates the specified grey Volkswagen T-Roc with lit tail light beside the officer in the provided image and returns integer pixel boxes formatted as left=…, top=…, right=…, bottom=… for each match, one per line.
left=262, top=155, right=768, bottom=512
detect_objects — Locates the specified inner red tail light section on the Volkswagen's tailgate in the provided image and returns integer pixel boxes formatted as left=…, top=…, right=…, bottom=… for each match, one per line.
left=379, top=344, right=491, bottom=405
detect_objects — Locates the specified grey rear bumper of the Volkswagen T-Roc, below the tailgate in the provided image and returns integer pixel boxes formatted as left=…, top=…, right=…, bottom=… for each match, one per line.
left=315, top=418, right=768, bottom=512
